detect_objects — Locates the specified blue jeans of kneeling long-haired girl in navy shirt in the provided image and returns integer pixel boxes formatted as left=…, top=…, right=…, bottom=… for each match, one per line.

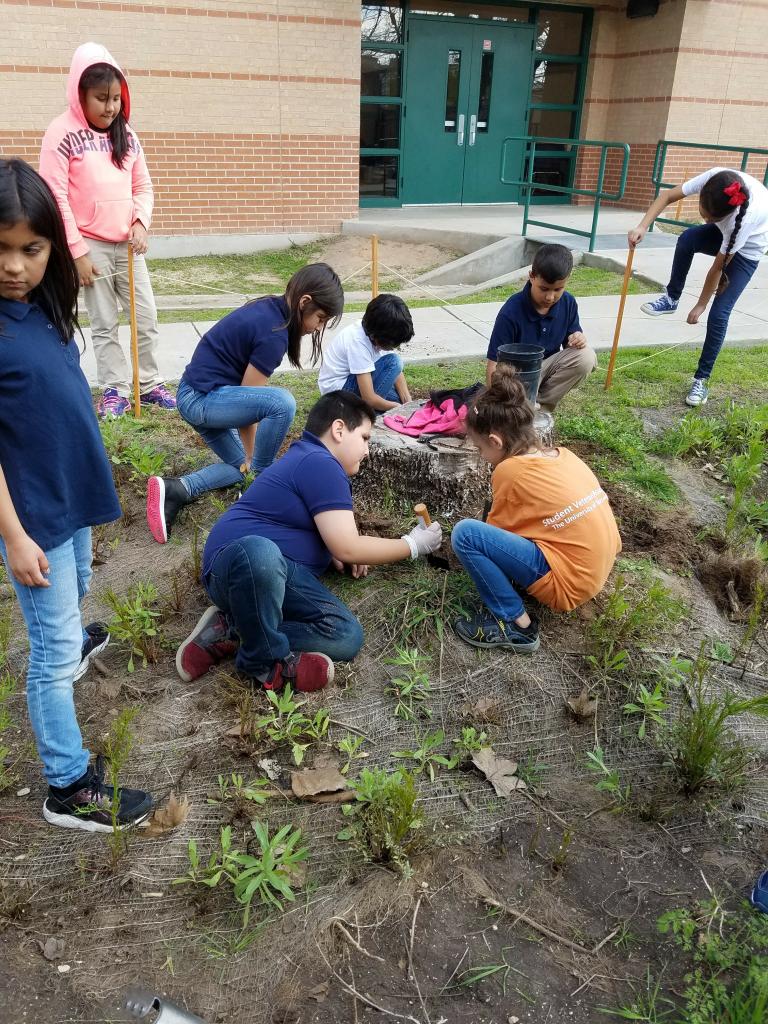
left=176, top=378, right=296, bottom=498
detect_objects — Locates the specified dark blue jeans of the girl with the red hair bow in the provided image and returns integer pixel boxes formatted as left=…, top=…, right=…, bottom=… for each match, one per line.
left=667, top=224, right=759, bottom=380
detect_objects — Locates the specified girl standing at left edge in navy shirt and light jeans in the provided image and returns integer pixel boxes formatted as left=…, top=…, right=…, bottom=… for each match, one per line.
left=0, top=160, right=152, bottom=831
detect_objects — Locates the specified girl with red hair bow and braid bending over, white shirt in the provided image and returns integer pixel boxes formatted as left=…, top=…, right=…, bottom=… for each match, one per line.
left=628, top=167, right=768, bottom=406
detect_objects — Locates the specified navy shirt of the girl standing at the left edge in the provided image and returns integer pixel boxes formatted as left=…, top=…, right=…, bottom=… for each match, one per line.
left=0, top=299, right=121, bottom=551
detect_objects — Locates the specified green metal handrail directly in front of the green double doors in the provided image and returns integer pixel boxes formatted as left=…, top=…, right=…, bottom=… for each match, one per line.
left=501, top=135, right=630, bottom=252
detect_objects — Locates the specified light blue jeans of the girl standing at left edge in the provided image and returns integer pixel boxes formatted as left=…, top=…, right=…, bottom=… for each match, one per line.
left=0, top=527, right=92, bottom=787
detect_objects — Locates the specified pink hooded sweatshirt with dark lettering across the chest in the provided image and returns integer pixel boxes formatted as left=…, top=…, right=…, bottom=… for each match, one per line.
left=40, top=43, right=155, bottom=259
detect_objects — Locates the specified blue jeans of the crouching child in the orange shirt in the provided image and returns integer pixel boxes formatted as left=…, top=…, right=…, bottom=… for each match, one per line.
left=451, top=519, right=549, bottom=622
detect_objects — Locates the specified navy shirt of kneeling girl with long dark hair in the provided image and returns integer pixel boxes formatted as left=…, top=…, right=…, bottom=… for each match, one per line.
left=183, top=295, right=289, bottom=394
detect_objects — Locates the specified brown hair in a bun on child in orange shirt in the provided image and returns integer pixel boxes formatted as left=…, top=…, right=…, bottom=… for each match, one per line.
left=467, top=362, right=542, bottom=456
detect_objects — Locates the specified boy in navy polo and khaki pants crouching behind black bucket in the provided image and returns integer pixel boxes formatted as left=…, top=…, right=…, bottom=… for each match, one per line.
left=485, top=245, right=597, bottom=413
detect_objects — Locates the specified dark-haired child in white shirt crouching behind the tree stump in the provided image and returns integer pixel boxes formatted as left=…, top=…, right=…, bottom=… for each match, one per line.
left=317, top=293, right=414, bottom=413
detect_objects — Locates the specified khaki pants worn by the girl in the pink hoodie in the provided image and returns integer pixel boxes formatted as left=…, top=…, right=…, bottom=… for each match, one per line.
left=83, top=239, right=163, bottom=398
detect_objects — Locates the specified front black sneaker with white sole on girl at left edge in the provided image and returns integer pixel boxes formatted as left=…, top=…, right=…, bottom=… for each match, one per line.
left=43, top=756, right=153, bottom=833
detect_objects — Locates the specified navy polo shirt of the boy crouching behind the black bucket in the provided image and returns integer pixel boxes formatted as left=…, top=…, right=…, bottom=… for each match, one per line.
left=486, top=281, right=582, bottom=362
